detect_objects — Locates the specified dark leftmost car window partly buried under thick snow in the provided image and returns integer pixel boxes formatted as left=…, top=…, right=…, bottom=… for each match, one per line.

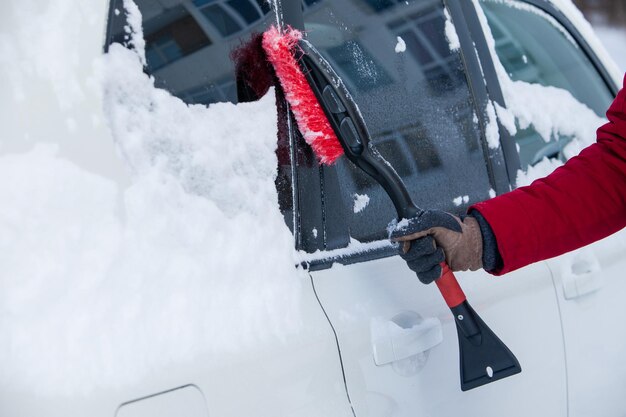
left=105, top=0, right=293, bottom=234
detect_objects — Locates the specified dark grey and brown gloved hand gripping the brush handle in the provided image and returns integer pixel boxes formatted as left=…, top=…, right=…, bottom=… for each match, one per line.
left=390, top=210, right=483, bottom=284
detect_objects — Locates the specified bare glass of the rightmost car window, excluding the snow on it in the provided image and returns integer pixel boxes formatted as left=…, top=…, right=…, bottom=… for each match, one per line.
left=481, top=0, right=613, bottom=170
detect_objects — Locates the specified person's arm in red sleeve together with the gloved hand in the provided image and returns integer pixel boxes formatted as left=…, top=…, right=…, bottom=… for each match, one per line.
left=391, top=76, right=626, bottom=282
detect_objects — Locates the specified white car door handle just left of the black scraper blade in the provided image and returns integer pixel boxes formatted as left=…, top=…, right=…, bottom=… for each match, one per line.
left=370, top=311, right=443, bottom=366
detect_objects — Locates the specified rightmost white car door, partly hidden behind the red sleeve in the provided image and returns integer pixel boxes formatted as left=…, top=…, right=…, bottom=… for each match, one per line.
left=470, top=0, right=626, bottom=416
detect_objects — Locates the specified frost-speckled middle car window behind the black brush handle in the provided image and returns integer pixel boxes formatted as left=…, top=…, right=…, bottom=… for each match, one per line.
left=304, top=0, right=491, bottom=242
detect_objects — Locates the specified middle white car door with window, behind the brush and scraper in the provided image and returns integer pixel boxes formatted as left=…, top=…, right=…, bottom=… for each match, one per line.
left=286, top=0, right=566, bottom=416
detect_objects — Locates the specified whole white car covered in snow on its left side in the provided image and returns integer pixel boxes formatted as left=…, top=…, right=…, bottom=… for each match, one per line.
left=0, top=0, right=626, bottom=417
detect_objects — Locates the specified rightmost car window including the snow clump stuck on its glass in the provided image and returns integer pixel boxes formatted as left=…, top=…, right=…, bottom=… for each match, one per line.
left=474, top=0, right=612, bottom=186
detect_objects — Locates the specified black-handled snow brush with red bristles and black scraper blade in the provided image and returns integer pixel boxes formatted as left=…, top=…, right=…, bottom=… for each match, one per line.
left=262, top=27, right=522, bottom=391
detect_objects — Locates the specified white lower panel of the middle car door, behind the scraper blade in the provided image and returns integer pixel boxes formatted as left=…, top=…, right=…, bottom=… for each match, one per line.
left=312, top=250, right=567, bottom=416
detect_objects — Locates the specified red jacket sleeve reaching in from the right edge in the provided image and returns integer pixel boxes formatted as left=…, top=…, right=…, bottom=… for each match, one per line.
left=470, top=76, right=626, bottom=275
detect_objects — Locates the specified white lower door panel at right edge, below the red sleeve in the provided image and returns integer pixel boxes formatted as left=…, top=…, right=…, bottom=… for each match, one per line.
left=547, top=230, right=626, bottom=417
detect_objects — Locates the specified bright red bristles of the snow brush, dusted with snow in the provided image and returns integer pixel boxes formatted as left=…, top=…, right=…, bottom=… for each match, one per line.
left=263, top=26, right=343, bottom=165
